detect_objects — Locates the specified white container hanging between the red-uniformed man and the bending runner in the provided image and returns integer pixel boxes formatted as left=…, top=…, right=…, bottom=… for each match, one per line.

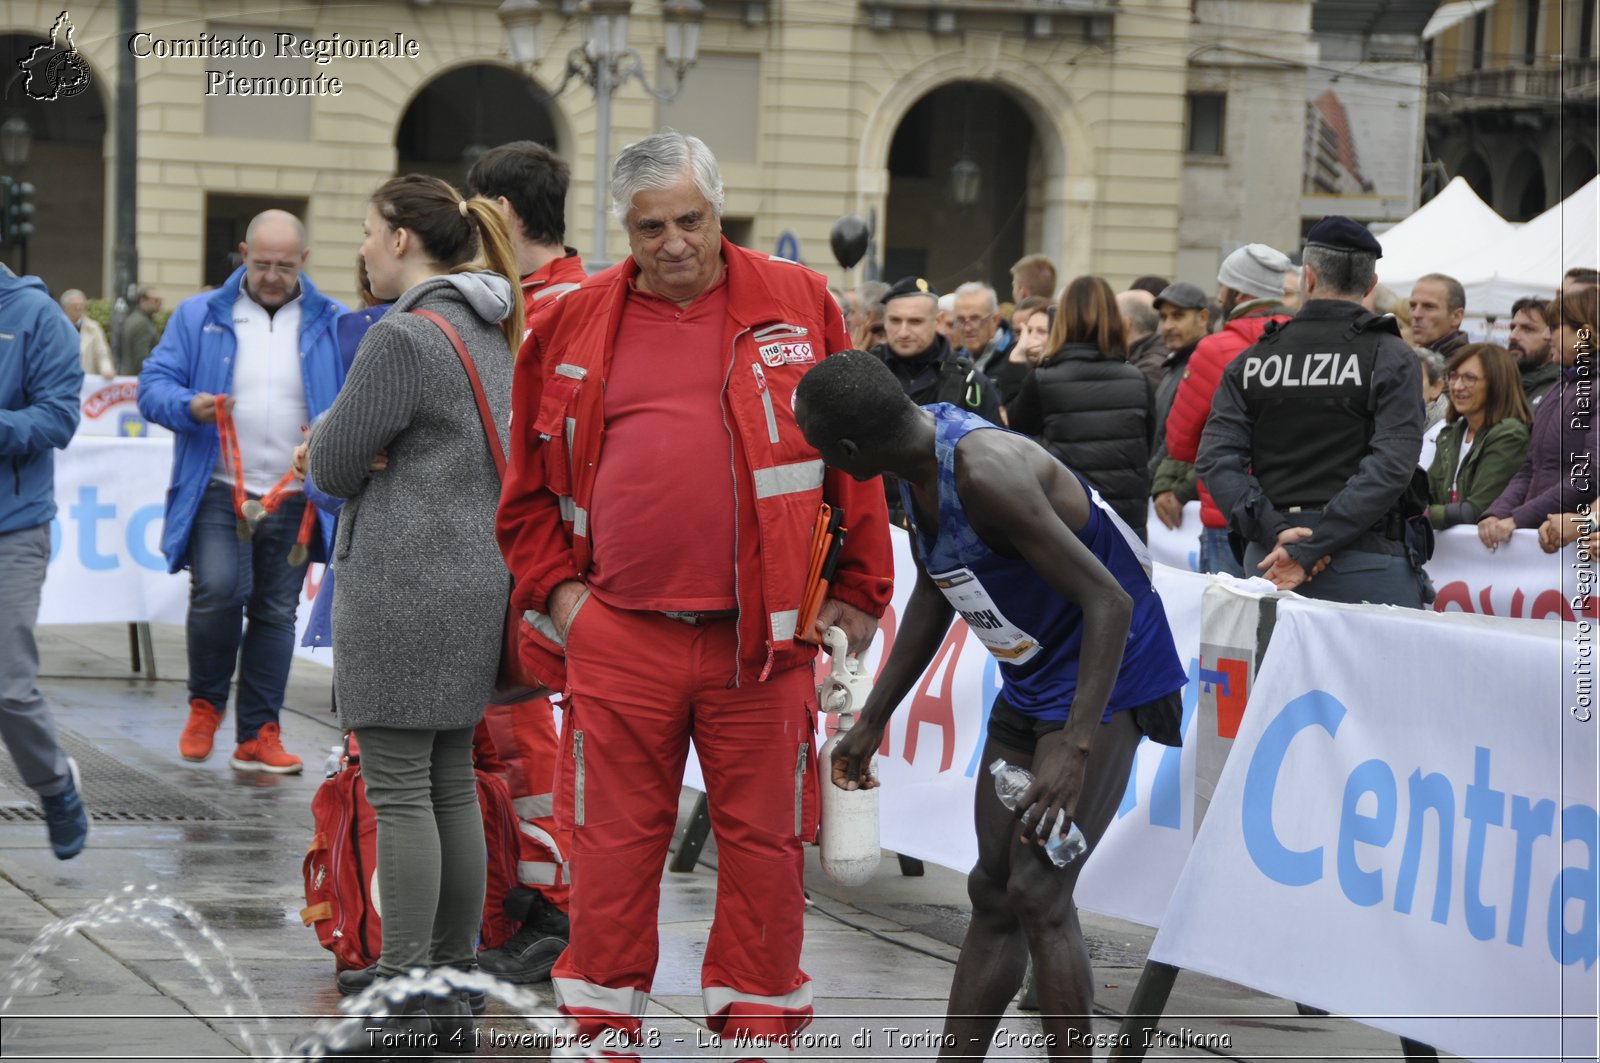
left=818, top=628, right=883, bottom=885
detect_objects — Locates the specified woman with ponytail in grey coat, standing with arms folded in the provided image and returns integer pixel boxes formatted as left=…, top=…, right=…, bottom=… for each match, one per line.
left=309, top=174, right=523, bottom=1023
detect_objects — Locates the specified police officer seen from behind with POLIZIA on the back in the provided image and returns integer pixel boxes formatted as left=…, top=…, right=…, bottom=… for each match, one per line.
left=1195, top=216, right=1426, bottom=608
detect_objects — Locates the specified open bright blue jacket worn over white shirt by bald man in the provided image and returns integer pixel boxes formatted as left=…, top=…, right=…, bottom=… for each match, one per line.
left=139, top=266, right=347, bottom=572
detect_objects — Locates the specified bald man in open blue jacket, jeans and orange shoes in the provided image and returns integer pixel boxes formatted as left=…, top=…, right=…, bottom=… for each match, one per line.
left=139, top=210, right=346, bottom=775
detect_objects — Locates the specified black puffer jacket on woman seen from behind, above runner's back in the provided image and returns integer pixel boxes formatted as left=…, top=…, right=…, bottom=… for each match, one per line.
left=1006, top=343, right=1155, bottom=536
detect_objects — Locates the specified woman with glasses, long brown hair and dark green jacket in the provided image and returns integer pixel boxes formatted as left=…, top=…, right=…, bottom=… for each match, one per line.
left=1427, top=343, right=1533, bottom=528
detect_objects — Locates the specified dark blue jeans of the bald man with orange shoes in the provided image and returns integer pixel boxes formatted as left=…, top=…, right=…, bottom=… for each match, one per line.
left=189, top=480, right=306, bottom=743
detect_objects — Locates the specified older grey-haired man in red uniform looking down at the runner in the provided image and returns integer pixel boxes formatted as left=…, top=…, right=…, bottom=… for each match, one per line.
left=499, top=133, right=893, bottom=1058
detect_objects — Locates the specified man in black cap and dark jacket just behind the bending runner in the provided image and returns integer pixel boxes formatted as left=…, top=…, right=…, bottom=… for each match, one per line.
left=872, top=277, right=1003, bottom=528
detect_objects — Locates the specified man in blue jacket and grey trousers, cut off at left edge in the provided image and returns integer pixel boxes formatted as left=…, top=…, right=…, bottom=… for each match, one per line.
left=0, top=266, right=90, bottom=860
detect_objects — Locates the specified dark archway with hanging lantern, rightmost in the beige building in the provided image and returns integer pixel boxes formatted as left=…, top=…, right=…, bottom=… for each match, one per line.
left=883, top=82, right=1037, bottom=299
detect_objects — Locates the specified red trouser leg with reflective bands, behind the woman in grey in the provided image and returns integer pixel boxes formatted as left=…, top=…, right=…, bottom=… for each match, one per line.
left=482, top=698, right=571, bottom=911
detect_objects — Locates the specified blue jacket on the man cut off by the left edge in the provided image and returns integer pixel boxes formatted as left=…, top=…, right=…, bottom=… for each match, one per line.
left=0, top=266, right=83, bottom=532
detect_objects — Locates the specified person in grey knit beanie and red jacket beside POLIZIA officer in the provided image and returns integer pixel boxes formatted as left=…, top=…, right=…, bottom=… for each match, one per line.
left=1166, top=243, right=1294, bottom=578
